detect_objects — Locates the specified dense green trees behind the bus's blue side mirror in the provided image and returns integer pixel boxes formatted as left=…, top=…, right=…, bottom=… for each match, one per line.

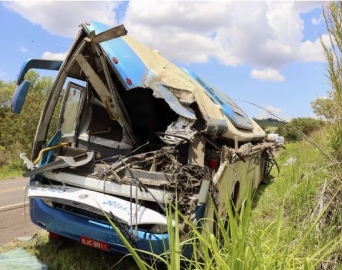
left=0, top=71, right=52, bottom=167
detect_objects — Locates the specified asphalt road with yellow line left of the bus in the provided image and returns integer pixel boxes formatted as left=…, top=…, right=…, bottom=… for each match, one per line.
left=0, top=178, right=40, bottom=246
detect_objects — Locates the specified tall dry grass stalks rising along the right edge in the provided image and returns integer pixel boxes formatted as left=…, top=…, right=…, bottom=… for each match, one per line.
left=321, top=1, right=342, bottom=267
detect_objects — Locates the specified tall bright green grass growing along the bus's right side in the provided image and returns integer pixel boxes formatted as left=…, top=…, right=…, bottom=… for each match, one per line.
left=104, top=130, right=342, bottom=269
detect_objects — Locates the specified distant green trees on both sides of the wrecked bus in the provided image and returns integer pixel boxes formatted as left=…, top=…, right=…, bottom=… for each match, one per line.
left=0, top=68, right=335, bottom=170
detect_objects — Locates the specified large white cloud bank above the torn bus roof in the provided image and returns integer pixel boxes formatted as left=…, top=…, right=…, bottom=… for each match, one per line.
left=124, top=1, right=323, bottom=70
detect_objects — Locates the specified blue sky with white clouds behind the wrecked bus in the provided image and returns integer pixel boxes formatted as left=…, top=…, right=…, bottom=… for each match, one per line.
left=0, top=0, right=330, bottom=120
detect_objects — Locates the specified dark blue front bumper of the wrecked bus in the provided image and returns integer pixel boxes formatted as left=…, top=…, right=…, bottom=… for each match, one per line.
left=30, top=199, right=169, bottom=255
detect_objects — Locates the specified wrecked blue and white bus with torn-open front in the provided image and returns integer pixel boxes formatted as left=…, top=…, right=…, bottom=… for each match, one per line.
left=11, top=21, right=274, bottom=254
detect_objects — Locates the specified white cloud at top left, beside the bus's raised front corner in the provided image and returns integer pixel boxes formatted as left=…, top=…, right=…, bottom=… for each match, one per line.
left=4, top=1, right=118, bottom=37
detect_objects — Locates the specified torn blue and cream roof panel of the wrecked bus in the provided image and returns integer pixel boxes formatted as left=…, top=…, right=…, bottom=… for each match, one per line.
left=83, top=22, right=265, bottom=141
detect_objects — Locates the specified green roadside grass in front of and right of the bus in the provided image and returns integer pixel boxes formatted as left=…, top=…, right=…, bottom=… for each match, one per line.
left=0, top=128, right=342, bottom=269
